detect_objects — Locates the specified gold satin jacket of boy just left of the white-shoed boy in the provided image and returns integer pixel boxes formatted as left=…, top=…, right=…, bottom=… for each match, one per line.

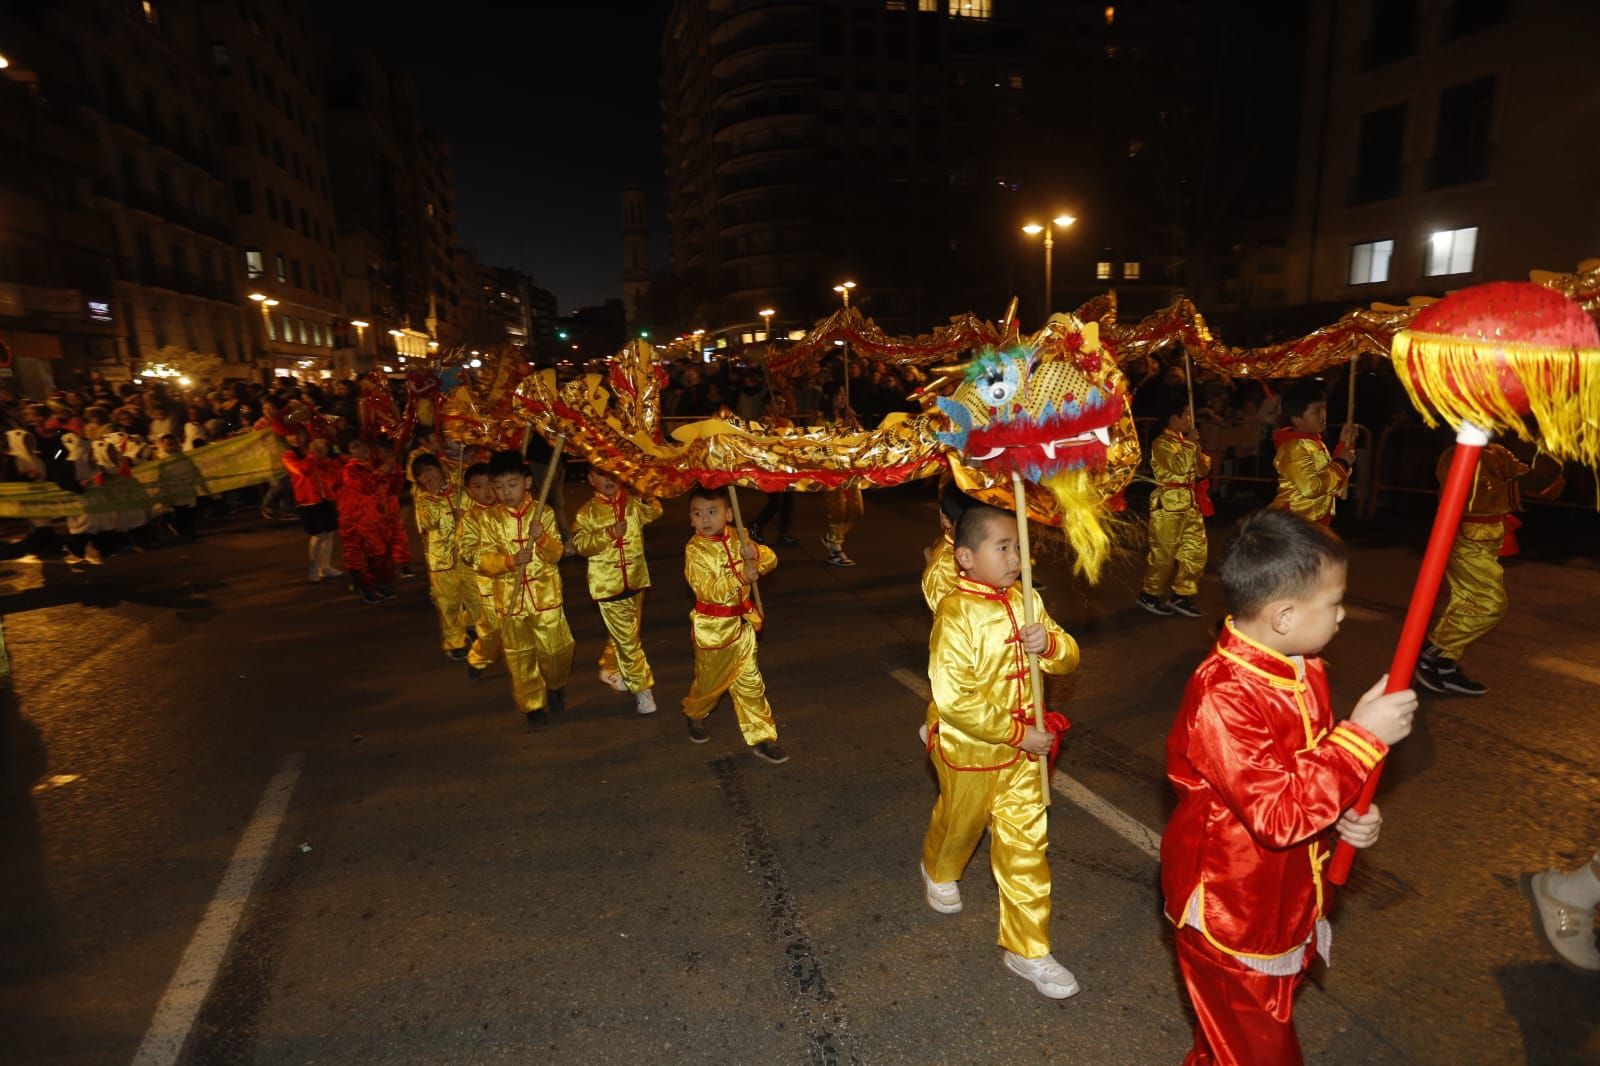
left=461, top=496, right=562, bottom=618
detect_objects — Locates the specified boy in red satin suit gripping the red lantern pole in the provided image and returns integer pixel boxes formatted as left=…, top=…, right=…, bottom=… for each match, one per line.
left=1162, top=509, right=1416, bottom=1066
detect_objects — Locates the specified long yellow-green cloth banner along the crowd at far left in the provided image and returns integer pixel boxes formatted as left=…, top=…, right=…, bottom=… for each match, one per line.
left=0, top=429, right=285, bottom=519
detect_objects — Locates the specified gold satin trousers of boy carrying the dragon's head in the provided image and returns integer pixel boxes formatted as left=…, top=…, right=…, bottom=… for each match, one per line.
left=922, top=749, right=1050, bottom=959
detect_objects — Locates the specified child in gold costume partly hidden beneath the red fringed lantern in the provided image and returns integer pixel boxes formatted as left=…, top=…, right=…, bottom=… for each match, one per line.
left=1414, top=443, right=1563, bottom=696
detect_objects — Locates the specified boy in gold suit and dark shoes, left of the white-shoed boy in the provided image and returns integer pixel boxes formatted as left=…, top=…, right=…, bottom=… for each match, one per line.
left=461, top=451, right=573, bottom=728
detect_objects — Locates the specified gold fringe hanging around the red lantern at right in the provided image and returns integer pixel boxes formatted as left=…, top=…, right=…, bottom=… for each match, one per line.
left=1394, top=330, right=1600, bottom=467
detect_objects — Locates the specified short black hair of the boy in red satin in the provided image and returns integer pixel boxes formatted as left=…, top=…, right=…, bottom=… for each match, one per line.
left=1218, top=509, right=1349, bottom=619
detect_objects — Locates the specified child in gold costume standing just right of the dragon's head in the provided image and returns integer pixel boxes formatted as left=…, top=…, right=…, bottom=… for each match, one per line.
left=1139, top=403, right=1211, bottom=618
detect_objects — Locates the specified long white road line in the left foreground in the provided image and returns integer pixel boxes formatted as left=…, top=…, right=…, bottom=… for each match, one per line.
left=133, top=745, right=306, bottom=1066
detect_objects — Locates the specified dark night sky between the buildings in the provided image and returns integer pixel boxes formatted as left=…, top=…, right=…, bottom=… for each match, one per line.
left=324, top=0, right=670, bottom=312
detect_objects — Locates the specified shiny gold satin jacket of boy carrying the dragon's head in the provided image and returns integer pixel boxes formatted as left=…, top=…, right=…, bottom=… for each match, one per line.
left=928, top=576, right=1078, bottom=770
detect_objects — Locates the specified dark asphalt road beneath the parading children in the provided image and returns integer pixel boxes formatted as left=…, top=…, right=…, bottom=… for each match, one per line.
left=0, top=487, right=1600, bottom=1064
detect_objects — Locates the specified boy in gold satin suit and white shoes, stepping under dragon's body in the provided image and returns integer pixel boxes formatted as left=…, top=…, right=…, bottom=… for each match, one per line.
left=573, top=466, right=661, bottom=714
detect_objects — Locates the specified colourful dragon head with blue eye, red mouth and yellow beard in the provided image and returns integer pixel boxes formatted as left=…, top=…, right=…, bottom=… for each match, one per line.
left=934, top=315, right=1139, bottom=581
